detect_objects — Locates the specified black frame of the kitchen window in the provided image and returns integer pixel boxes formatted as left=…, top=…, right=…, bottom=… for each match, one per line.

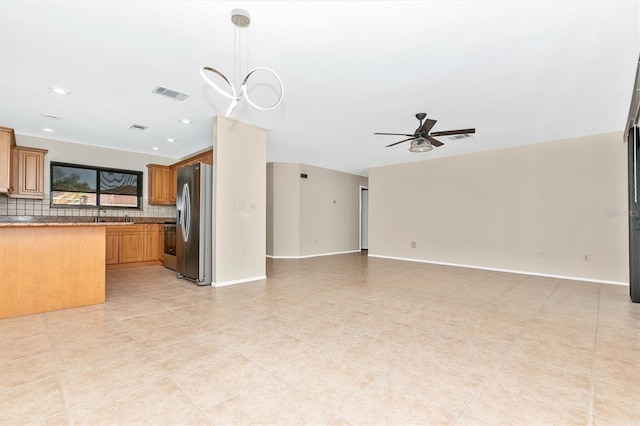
left=49, top=161, right=143, bottom=210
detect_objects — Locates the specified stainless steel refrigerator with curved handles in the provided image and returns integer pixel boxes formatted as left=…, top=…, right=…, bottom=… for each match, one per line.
left=176, top=163, right=213, bottom=285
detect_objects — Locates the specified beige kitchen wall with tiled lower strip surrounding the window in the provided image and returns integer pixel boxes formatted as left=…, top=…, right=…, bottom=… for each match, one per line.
left=0, top=134, right=176, bottom=217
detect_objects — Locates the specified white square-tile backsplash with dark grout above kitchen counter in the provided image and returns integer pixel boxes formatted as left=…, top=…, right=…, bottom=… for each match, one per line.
left=0, top=195, right=176, bottom=218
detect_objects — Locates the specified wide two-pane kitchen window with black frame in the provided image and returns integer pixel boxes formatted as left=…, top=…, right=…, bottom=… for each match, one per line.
left=51, top=162, right=142, bottom=209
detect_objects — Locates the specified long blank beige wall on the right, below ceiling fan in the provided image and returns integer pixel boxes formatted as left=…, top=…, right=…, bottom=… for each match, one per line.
left=369, top=132, right=628, bottom=283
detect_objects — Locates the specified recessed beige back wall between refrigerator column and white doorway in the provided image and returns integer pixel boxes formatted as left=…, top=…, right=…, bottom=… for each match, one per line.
left=267, top=163, right=367, bottom=257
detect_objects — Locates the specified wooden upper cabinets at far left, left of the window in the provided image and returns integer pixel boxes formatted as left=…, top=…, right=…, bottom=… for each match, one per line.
left=0, top=127, right=47, bottom=199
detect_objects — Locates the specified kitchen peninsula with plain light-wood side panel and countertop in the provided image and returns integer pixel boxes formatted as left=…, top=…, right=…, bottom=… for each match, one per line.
left=0, top=222, right=130, bottom=318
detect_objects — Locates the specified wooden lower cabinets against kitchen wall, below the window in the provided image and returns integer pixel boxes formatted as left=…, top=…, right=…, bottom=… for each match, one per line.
left=105, top=224, right=161, bottom=268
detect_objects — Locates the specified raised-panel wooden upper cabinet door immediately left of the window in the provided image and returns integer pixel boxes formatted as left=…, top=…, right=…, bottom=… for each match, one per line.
left=10, top=147, right=47, bottom=199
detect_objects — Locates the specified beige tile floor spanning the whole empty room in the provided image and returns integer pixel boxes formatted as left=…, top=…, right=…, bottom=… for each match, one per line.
left=0, top=254, right=640, bottom=425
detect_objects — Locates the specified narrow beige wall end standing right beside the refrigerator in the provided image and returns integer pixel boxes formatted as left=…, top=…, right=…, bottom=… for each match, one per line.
left=213, top=117, right=267, bottom=286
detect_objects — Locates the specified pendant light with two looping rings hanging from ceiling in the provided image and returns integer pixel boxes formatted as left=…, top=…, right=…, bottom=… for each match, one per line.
left=200, top=9, right=284, bottom=117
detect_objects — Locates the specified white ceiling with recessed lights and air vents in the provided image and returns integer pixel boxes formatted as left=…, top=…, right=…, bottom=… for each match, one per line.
left=0, top=0, right=640, bottom=175
